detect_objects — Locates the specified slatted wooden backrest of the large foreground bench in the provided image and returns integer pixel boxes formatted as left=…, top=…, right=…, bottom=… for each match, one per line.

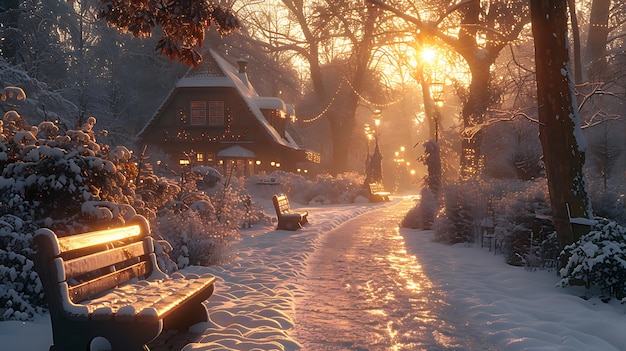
left=34, top=216, right=158, bottom=309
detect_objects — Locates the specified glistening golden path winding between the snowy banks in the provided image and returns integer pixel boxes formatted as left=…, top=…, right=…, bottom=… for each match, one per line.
left=293, top=199, right=497, bottom=351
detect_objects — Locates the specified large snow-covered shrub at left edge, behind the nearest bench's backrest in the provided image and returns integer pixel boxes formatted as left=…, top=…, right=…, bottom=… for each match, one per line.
left=0, top=111, right=137, bottom=233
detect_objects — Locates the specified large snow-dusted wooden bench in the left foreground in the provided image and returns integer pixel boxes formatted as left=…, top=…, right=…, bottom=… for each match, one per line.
left=33, top=216, right=215, bottom=351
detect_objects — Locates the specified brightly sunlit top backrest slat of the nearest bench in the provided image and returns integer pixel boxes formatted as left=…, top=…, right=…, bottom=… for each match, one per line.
left=58, top=225, right=141, bottom=252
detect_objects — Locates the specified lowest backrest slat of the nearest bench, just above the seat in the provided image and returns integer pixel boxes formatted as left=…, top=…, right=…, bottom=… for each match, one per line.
left=69, top=261, right=149, bottom=302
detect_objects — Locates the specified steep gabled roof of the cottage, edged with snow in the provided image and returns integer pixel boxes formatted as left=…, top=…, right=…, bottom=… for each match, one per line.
left=139, top=50, right=301, bottom=149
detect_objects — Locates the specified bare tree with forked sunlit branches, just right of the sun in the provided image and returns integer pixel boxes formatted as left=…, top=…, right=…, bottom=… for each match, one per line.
left=368, top=0, right=529, bottom=179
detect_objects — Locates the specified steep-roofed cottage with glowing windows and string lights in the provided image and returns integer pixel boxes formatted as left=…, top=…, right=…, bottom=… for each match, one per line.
left=138, top=50, right=320, bottom=175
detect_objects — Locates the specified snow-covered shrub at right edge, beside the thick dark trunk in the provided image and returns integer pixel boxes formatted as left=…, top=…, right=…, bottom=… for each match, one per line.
left=559, top=217, right=626, bottom=299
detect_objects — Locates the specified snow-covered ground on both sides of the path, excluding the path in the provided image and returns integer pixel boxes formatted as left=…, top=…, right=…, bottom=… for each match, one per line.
left=0, top=198, right=626, bottom=351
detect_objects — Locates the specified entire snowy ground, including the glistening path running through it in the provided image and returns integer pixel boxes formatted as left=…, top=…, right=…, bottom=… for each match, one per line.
left=0, top=197, right=626, bottom=351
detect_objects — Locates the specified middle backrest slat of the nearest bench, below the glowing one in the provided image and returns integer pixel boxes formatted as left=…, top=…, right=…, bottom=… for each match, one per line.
left=65, top=241, right=150, bottom=279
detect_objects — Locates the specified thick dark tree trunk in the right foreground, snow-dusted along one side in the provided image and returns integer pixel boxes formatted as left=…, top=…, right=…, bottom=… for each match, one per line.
left=530, top=0, right=592, bottom=248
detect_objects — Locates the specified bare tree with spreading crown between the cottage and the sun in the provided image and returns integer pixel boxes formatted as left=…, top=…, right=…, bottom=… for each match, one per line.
left=241, top=0, right=392, bottom=173
